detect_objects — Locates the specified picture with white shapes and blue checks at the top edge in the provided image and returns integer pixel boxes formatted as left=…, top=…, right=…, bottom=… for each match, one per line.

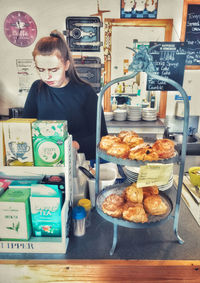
left=120, top=0, right=158, bottom=19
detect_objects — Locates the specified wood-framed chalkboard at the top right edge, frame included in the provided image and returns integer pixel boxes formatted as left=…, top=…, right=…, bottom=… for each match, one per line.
left=181, top=0, right=200, bottom=70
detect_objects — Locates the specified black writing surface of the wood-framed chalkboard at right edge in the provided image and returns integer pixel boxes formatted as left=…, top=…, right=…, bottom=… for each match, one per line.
left=185, top=5, right=200, bottom=65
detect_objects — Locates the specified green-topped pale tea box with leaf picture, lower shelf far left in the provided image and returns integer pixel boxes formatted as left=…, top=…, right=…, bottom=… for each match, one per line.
left=0, top=188, right=32, bottom=240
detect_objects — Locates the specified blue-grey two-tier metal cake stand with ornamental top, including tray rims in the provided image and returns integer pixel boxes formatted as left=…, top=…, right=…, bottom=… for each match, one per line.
left=96, top=48, right=189, bottom=255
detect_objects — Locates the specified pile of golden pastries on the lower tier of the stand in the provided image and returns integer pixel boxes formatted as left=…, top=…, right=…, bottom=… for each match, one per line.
left=101, top=183, right=168, bottom=223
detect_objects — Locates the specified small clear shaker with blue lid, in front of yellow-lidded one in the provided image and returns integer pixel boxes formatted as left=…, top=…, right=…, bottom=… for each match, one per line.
left=72, top=206, right=86, bottom=237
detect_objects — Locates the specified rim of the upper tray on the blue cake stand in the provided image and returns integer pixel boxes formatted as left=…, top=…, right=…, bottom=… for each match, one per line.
left=97, top=147, right=180, bottom=166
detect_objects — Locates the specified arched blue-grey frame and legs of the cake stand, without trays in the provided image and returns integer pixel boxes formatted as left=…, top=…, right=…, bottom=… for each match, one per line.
left=96, top=46, right=189, bottom=255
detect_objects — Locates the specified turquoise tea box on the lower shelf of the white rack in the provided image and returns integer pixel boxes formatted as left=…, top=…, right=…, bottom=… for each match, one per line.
left=30, top=184, right=62, bottom=237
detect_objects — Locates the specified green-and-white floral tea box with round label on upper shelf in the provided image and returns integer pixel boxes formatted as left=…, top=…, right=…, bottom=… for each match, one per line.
left=32, top=120, right=68, bottom=167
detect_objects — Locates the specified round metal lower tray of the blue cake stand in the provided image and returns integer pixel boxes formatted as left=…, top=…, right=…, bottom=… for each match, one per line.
left=96, top=184, right=173, bottom=228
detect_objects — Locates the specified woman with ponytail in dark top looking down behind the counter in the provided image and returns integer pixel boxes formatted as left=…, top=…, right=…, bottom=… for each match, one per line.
left=23, top=30, right=107, bottom=160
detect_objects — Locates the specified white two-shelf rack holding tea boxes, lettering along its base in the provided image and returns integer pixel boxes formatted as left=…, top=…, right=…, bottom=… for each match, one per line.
left=0, top=127, right=73, bottom=254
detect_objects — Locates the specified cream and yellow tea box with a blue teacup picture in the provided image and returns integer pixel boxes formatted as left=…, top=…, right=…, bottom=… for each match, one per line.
left=3, top=118, right=36, bottom=166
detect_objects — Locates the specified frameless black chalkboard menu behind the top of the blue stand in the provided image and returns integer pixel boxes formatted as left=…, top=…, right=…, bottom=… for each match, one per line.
left=147, top=42, right=187, bottom=91
